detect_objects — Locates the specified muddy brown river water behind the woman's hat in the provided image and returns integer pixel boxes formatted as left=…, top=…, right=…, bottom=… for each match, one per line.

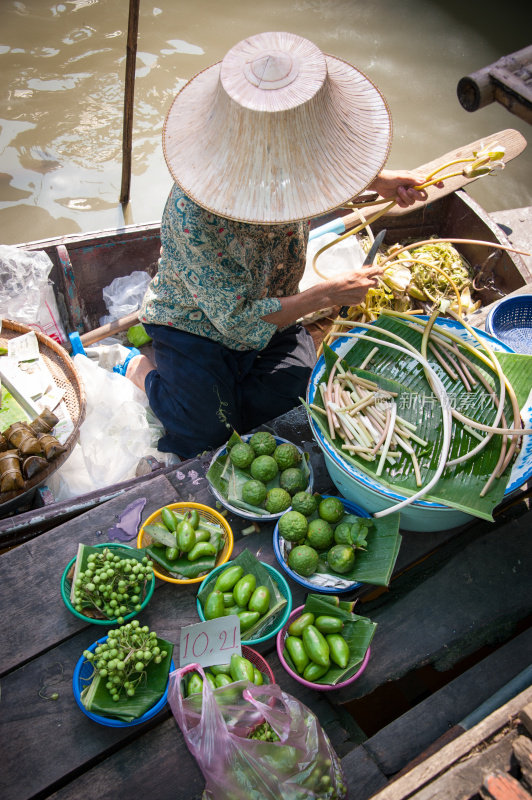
left=0, top=0, right=532, bottom=247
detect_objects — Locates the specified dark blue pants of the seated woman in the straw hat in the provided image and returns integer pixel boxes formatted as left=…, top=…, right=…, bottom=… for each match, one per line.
left=144, top=324, right=316, bottom=459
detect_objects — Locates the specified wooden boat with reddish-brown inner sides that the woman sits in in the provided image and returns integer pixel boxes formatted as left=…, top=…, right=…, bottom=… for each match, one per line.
left=0, top=184, right=532, bottom=549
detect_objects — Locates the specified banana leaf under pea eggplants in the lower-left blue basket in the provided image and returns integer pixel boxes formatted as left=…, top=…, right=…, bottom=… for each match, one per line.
left=81, top=638, right=174, bottom=722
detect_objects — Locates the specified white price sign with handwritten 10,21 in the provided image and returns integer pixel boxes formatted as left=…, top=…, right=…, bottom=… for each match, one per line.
left=179, top=614, right=242, bottom=667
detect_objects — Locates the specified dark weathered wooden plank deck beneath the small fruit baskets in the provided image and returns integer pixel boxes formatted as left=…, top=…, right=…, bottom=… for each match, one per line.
left=0, top=409, right=532, bottom=800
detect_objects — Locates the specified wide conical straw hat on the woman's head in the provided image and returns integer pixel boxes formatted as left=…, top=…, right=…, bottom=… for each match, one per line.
left=163, top=33, right=391, bottom=224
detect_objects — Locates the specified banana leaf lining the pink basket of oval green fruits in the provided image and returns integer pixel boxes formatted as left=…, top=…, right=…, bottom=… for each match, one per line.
left=283, top=594, right=377, bottom=686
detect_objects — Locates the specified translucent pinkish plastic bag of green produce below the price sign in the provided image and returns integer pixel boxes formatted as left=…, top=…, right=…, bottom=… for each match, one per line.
left=168, top=664, right=346, bottom=800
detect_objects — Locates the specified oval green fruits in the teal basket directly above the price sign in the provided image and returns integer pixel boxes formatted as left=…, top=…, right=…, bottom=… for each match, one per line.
left=203, top=564, right=271, bottom=633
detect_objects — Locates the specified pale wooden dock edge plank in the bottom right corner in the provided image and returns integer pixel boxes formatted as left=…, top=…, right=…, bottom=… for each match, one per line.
left=364, top=686, right=532, bottom=800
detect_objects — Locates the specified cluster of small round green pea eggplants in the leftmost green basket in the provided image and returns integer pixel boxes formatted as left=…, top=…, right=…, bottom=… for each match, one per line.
left=73, top=547, right=153, bottom=624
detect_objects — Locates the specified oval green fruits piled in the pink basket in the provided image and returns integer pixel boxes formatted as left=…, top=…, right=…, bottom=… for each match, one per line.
left=284, top=611, right=349, bottom=683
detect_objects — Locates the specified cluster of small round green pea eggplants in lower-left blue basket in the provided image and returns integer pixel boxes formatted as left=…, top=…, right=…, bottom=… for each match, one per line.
left=83, top=620, right=168, bottom=702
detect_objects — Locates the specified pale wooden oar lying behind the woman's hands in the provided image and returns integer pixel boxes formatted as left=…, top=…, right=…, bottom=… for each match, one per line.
left=310, top=128, right=527, bottom=239
